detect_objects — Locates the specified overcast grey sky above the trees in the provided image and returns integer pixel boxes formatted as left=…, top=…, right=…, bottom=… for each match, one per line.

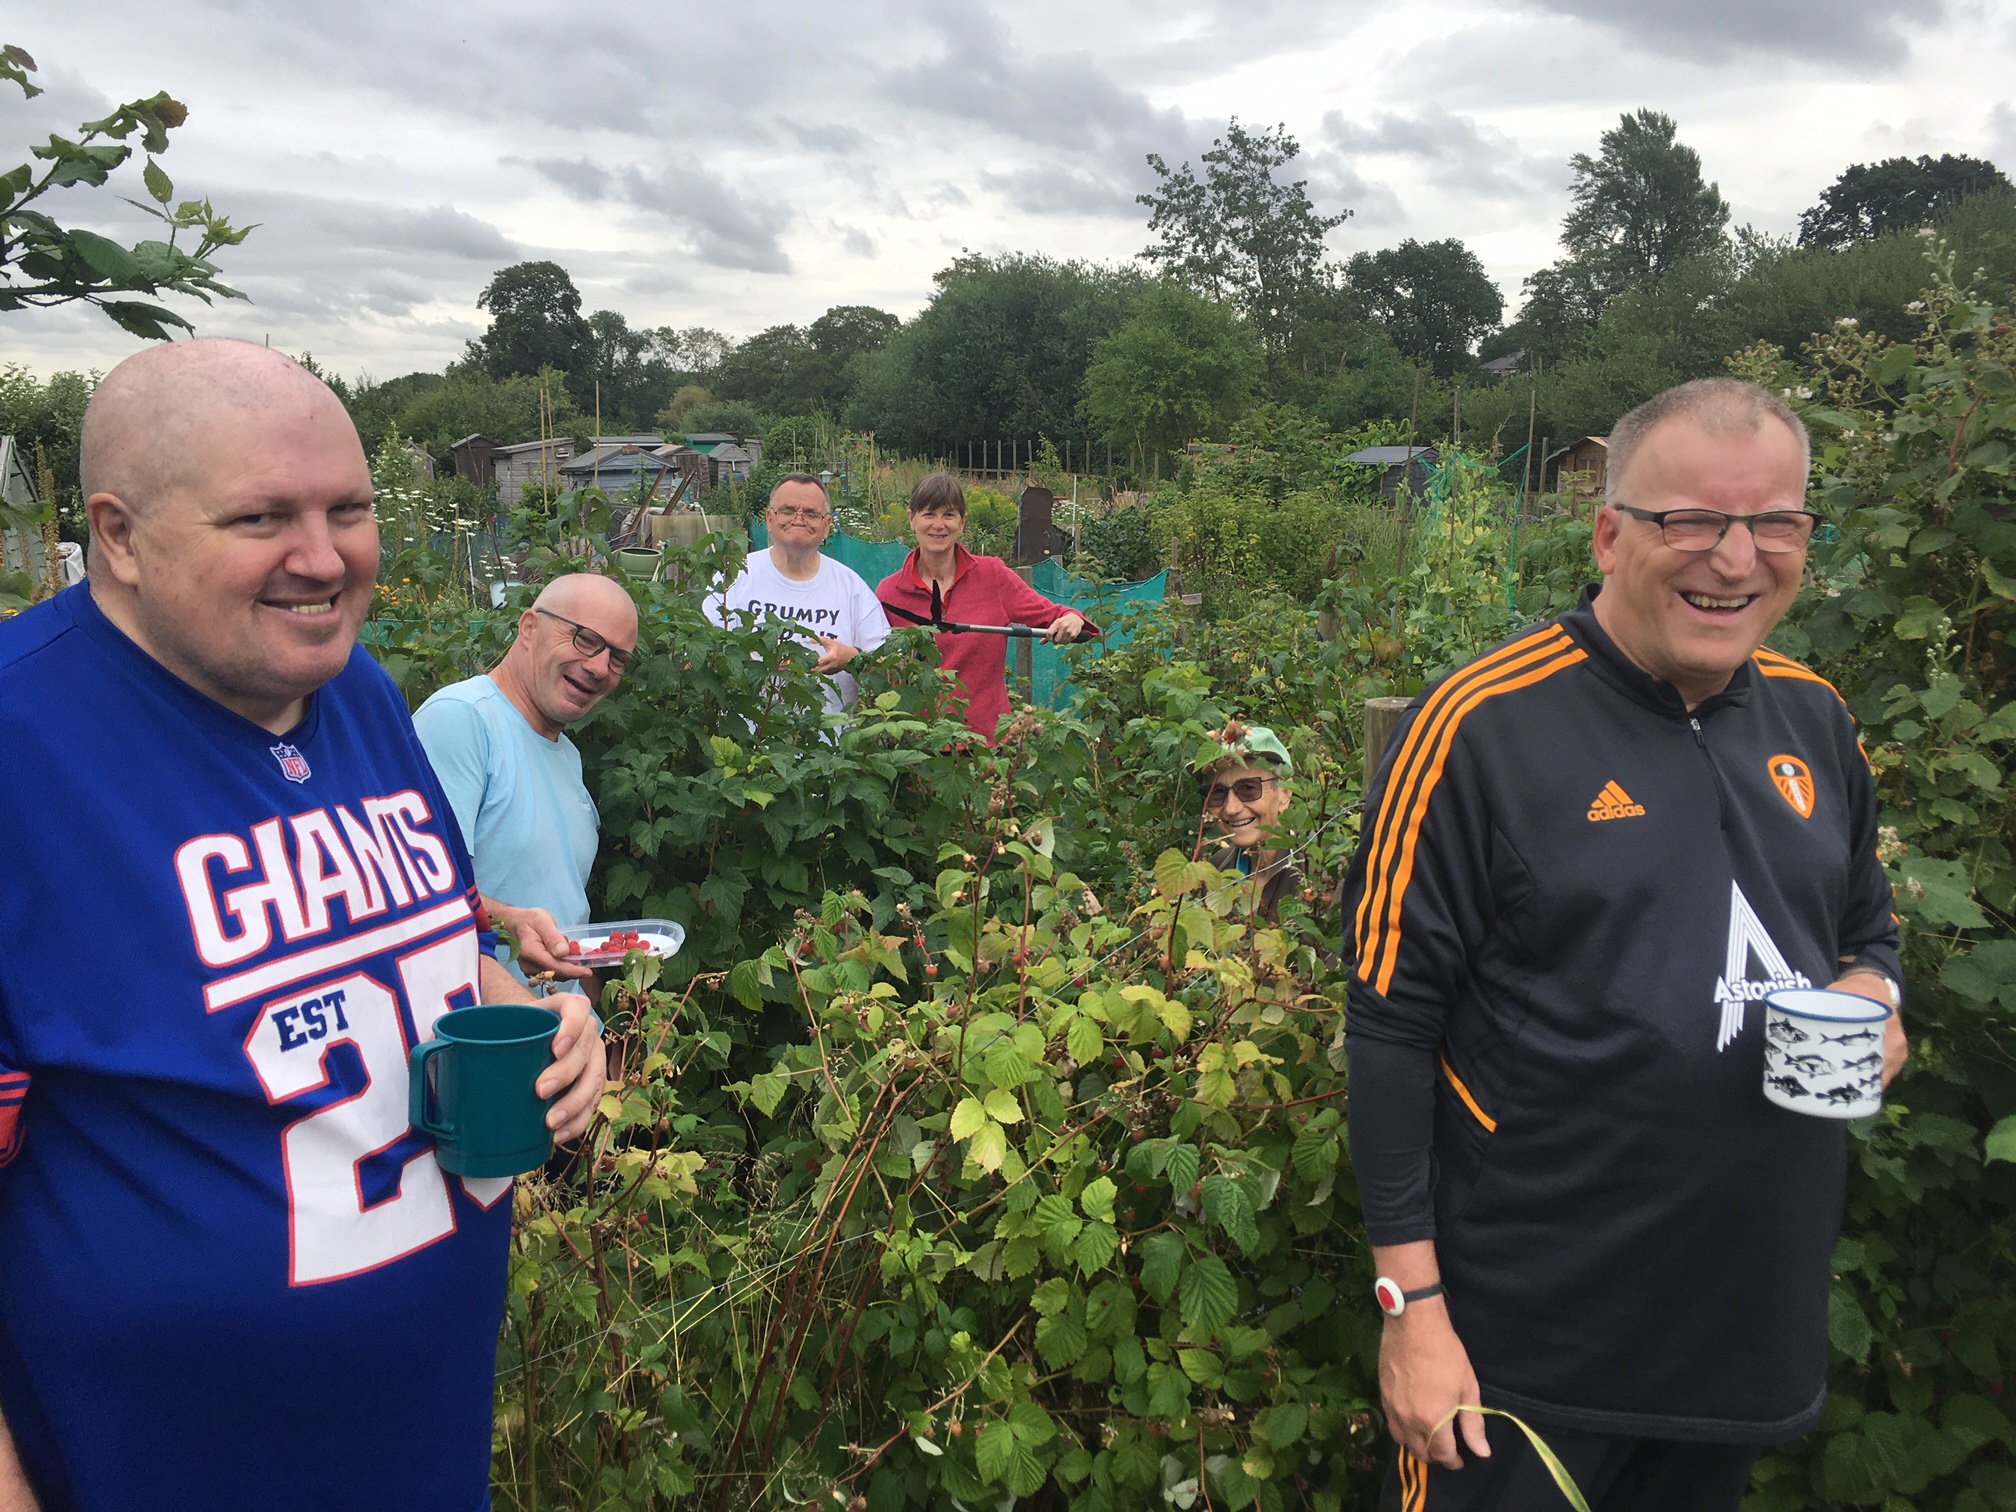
left=0, top=0, right=2016, bottom=377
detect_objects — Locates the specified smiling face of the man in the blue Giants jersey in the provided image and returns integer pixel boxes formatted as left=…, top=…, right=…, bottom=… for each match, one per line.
left=87, top=373, right=379, bottom=732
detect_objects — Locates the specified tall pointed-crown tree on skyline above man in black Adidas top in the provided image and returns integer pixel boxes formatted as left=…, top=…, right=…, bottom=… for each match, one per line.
left=1560, top=111, right=1730, bottom=286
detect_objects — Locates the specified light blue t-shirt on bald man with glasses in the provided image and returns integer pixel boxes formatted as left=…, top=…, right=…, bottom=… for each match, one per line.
left=413, top=677, right=601, bottom=970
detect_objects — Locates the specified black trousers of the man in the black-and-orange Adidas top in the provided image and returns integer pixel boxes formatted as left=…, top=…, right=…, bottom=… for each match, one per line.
left=1379, top=1417, right=1758, bottom=1512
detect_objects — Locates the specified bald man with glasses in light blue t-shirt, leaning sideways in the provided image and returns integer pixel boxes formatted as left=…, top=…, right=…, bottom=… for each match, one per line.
left=413, top=573, right=637, bottom=978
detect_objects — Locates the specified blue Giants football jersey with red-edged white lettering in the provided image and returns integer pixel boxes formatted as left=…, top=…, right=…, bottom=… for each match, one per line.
left=0, top=587, right=510, bottom=1512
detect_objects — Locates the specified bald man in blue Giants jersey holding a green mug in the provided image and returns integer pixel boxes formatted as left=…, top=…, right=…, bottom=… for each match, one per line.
left=0, top=341, right=603, bottom=1512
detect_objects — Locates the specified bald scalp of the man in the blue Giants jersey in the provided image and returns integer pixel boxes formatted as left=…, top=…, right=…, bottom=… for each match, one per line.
left=79, top=337, right=361, bottom=510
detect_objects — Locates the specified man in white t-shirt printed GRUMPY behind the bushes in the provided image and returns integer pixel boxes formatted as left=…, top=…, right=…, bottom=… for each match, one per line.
left=706, top=472, right=889, bottom=714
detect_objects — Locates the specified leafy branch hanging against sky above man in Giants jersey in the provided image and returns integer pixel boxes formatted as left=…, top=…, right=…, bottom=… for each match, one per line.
left=0, top=44, right=252, bottom=341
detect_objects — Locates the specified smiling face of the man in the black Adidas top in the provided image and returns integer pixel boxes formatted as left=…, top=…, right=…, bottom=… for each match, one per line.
left=1591, top=415, right=1806, bottom=708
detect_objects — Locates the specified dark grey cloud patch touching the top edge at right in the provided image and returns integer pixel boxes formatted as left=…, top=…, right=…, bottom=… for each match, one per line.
left=1534, top=0, right=1947, bottom=67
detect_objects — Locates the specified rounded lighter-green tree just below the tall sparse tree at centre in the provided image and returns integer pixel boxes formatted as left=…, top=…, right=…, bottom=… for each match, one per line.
left=1085, top=282, right=1260, bottom=468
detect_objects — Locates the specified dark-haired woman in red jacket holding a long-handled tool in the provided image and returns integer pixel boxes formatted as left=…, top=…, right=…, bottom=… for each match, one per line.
left=875, top=472, right=1099, bottom=742
